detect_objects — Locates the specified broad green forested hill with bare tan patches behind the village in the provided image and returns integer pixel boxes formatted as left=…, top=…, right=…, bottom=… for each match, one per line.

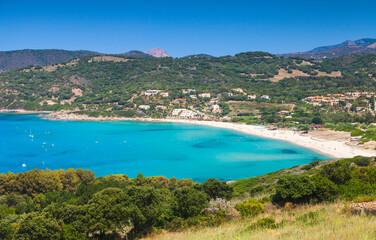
left=0, top=52, right=376, bottom=110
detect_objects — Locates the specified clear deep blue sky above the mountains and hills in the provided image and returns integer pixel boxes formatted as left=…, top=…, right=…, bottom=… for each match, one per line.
left=0, top=0, right=376, bottom=57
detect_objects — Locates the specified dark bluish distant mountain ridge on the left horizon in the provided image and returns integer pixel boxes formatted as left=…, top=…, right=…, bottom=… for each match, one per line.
left=0, top=49, right=99, bottom=70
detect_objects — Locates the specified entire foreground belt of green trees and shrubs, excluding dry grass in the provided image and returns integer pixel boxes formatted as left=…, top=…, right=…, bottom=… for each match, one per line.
left=0, top=156, right=376, bottom=240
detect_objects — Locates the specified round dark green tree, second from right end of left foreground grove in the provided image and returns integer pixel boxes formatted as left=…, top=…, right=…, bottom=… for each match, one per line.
left=171, top=187, right=209, bottom=218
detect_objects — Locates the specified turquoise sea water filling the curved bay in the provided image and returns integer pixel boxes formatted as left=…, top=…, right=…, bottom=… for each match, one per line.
left=0, top=114, right=329, bottom=182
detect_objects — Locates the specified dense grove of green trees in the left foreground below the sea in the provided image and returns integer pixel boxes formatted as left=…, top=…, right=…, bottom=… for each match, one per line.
left=0, top=169, right=232, bottom=240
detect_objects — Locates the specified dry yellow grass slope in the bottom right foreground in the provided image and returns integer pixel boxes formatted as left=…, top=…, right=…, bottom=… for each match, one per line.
left=145, top=204, right=376, bottom=240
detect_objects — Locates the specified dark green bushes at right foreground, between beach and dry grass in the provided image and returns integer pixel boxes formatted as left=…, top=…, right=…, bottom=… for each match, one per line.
left=272, top=156, right=376, bottom=204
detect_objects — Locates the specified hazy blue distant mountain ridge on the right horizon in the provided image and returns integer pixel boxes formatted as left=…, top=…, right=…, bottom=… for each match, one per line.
left=279, top=38, right=376, bottom=60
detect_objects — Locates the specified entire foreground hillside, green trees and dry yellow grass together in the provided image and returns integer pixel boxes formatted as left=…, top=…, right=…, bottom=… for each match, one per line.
left=0, top=157, right=376, bottom=240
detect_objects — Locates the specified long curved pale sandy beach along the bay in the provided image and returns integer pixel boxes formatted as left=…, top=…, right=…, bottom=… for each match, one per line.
left=39, top=113, right=376, bottom=158
